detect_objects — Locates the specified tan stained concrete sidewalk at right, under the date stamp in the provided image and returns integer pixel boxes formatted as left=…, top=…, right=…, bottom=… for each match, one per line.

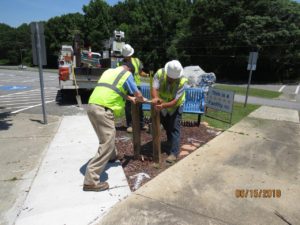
left=97, top=106, right=300, bottom=225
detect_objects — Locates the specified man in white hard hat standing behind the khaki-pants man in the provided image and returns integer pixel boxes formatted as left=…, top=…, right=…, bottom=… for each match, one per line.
left=120, top=44, right=149, bottom=133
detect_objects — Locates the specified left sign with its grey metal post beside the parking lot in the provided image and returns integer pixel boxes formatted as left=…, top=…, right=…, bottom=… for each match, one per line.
left=30, top=22, right=47, bottom=124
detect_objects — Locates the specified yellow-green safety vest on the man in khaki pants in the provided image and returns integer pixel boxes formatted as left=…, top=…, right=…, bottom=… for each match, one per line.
left=89, top=66, right=131, bottom=117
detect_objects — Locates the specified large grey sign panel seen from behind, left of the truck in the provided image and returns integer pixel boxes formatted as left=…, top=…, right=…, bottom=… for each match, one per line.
left=30, top=22, right=47, bottom=66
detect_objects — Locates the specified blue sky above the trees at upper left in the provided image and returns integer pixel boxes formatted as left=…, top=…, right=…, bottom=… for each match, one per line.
left=0, top=0, right=119, bottom=27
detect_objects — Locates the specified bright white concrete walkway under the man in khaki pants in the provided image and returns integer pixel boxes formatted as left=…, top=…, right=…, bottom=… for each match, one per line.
left=16, top=115, right=131, bottom=225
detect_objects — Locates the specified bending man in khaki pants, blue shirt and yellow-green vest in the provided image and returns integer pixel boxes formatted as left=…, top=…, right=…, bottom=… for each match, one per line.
left=83, top=62, right=145, bottom=191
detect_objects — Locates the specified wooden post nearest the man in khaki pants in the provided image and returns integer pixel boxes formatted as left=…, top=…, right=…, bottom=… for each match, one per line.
left=131, top=103, right=141, bottom=159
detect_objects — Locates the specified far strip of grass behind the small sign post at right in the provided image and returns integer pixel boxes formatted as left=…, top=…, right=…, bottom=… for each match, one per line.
left=214, top=84, right=281, bottom=99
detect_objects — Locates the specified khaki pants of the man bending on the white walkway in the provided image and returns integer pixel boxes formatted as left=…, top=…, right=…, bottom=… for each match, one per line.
left=84, top=104, right=116, bottom=185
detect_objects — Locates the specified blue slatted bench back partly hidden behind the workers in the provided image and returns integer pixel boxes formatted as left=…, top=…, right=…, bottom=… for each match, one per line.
left=141, top=85, right=205, bottom=114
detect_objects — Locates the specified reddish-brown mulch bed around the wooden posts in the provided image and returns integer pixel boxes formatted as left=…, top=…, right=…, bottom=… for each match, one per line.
left=116, top=122, right=219, bottom=191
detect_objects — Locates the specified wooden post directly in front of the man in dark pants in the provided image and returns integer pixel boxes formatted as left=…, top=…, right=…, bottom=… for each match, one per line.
left=151, top=107, right=161, bottom=164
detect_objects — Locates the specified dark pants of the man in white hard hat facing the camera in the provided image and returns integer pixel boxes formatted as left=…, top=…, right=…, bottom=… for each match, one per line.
left=160, top=109, right=181, bottom=156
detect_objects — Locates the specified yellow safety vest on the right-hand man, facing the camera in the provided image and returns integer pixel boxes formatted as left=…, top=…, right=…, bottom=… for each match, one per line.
left=157, top=68, right=187, bottom=114
